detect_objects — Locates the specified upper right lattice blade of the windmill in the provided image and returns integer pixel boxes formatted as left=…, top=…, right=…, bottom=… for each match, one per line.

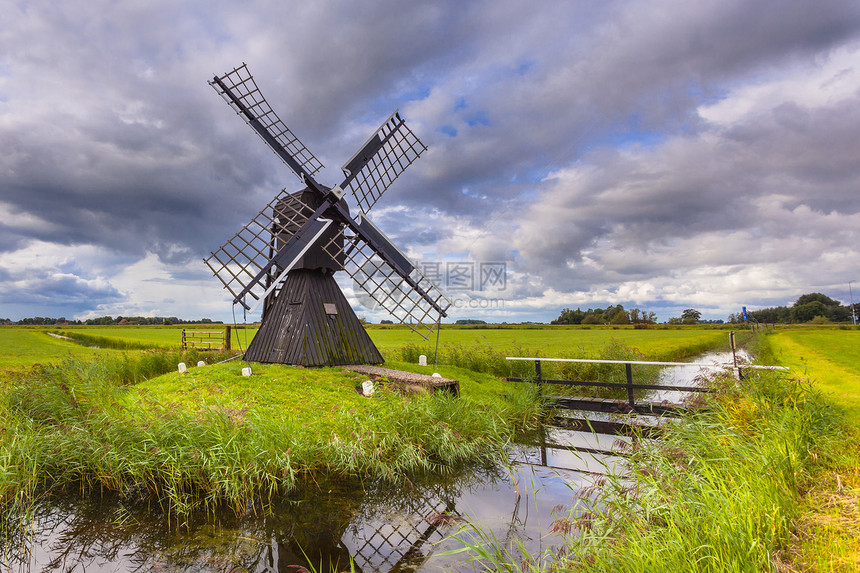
left=341, top=111, right=427, bottom=213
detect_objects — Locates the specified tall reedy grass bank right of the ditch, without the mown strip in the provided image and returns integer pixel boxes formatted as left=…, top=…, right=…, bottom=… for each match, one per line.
left=454, top=364, right=856, bottom=573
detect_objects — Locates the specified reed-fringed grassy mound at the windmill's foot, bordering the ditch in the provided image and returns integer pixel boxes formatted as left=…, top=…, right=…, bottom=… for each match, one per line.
left=0, top=353, right=539, bottom=513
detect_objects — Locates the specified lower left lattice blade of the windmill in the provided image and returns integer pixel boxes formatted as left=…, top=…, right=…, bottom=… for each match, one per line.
left=204, top=189, right=314, bottom=300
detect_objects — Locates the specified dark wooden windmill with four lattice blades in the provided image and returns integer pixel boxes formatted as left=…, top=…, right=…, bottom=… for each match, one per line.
left=205, top=64, right=451, bottom=366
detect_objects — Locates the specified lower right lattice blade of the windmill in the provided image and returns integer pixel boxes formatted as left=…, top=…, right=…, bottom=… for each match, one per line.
left=325, top=226, right=451, bottom=340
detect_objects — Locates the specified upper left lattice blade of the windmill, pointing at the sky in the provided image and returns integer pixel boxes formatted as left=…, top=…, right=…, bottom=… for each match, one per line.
left=209, top=64, right=323, bottom=182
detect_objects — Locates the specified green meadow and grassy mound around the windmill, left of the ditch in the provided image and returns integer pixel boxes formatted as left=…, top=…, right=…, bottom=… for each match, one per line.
left=0, top=325, right=726, bottom=509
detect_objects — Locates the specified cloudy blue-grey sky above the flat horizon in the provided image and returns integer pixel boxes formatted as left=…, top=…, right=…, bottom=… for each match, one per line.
left=0, top=0, right=860, bottom=322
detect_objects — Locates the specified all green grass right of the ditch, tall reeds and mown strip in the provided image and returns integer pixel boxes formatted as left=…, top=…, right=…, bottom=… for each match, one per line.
left=450, top=329, right=860, bottom=573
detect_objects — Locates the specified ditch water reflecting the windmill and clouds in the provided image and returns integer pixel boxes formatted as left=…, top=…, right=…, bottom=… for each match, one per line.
left=0, top=353, right=732, bottom=573
